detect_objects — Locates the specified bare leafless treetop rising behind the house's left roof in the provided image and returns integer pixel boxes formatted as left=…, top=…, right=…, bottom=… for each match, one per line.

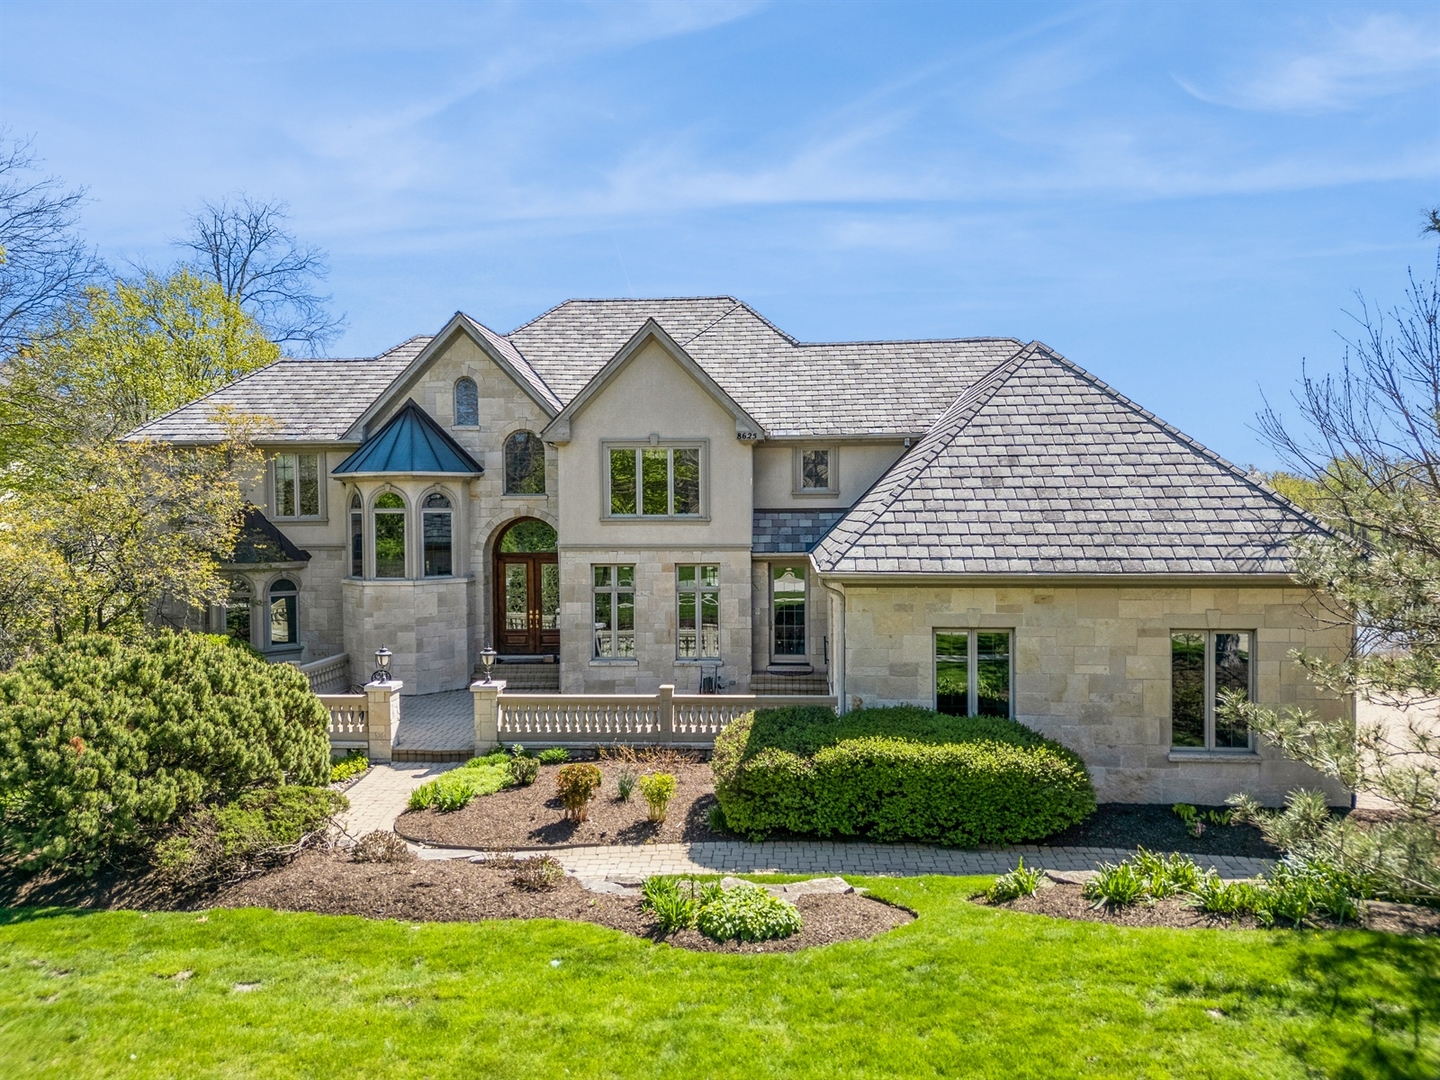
left=176, top=194, right=346, bottom=356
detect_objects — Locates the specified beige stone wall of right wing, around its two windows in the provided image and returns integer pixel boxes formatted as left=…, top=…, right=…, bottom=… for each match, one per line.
left=844, top=585, right=1349, bottom=805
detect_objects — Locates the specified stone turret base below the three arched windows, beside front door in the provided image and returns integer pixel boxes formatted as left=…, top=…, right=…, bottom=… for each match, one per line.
left=343, top=577, right=475, bottom=696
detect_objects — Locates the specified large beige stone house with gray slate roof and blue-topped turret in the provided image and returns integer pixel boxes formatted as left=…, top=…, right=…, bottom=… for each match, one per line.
left=137, top=297, right=1349, bottom=801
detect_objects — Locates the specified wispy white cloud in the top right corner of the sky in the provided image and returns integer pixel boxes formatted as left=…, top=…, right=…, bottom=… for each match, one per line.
left=1175, top=13, right=1440, bottom=112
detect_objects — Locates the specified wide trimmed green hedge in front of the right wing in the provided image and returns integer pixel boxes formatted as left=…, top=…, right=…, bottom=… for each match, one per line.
left=711, top=706, right=1094, bottom=845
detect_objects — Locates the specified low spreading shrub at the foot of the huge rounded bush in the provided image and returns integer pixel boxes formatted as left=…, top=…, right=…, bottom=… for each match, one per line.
left=154, top=785, right=350, bottom=887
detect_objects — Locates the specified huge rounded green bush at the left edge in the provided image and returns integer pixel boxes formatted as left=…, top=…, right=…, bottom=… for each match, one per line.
left=0, top=632, right=330, bottom=873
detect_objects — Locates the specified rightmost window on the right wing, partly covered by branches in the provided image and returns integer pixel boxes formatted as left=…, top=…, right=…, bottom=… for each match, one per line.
left=1171, top=631, right=1256, bottom=753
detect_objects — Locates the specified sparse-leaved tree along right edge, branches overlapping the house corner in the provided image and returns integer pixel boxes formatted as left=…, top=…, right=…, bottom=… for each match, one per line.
left=1225, top=216, right=1440, bottom=896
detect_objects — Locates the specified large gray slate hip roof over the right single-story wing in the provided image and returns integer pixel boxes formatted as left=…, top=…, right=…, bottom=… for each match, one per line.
left=814, top=344, right=1319, bottom=575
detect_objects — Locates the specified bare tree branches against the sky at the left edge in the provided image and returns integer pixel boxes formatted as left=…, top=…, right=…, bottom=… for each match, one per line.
left=0, top=131, right=104, bottom=357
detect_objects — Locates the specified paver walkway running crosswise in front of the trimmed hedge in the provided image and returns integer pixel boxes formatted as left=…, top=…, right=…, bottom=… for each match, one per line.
left=418, top=840, right=1272, bottom=880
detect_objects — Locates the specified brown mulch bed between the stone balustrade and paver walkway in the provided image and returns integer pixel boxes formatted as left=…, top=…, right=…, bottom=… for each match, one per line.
left=395, top=760, right=734, bottom=851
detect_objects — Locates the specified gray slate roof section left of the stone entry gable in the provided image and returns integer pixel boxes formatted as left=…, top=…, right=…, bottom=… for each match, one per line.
left=128, top=337, right=429, bottom=442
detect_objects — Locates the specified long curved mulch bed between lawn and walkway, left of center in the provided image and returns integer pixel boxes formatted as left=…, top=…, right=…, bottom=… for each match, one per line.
left=207, top=851, right=914, bottom=953
